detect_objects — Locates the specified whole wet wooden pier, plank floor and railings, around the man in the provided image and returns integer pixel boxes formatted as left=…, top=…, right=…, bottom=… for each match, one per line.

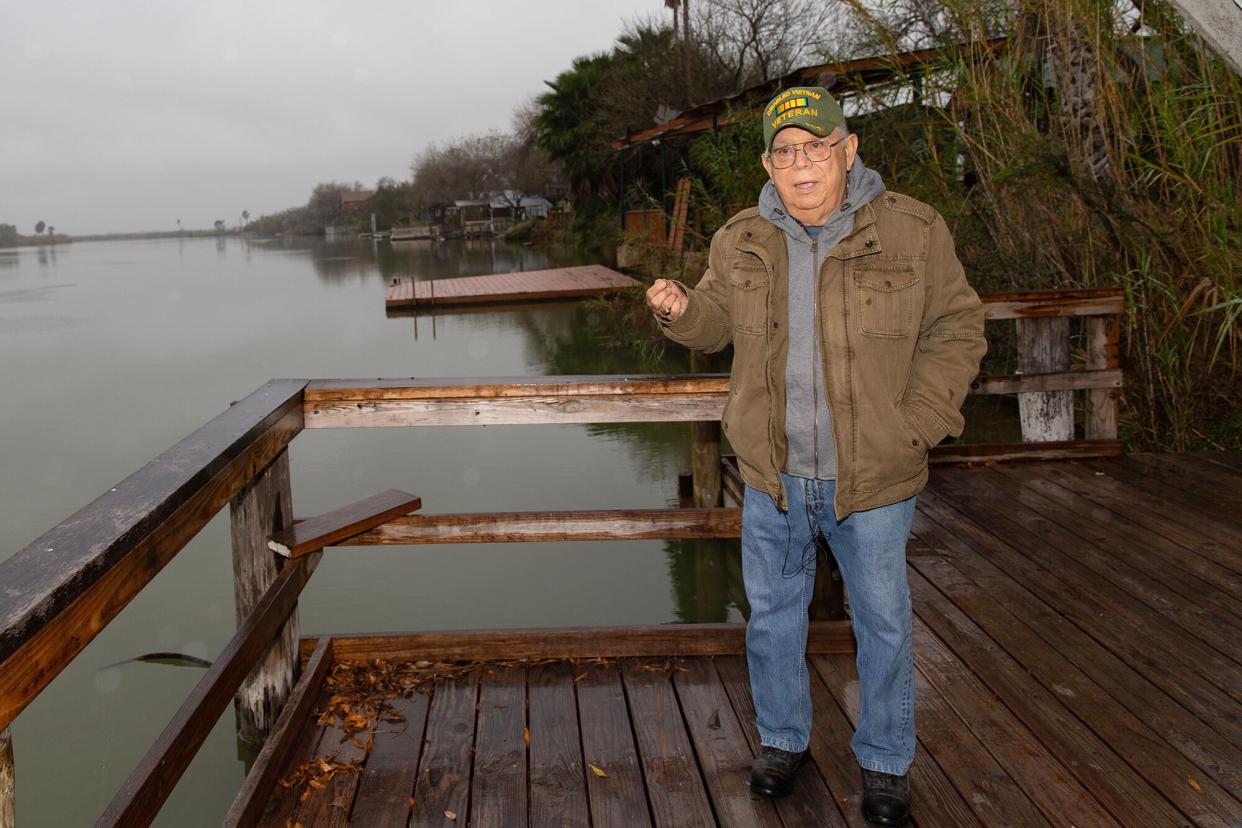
left=0, top=292, right=1242, bottom=828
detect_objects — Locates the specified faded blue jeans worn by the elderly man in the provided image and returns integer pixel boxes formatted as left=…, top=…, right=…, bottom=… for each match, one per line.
left=741, top=474, right=914, bottom=773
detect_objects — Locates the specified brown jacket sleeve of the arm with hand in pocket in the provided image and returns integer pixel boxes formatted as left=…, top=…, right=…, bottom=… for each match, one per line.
left=902, top=216, right=987, bottom=447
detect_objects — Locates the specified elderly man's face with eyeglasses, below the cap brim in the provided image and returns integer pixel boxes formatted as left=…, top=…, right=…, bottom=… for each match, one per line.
left=763, top=127, right=858, bottom=225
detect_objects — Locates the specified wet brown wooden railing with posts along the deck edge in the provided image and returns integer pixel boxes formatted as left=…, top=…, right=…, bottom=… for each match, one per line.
left=0, top=292, right=1122, bottom=826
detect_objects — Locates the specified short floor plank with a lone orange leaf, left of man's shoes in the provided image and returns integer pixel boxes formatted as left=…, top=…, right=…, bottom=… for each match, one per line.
left=575, top=663, right=651, bottom=828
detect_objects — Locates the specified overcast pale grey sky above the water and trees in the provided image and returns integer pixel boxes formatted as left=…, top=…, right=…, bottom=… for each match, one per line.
left=0, top=0, right=668, bottom=235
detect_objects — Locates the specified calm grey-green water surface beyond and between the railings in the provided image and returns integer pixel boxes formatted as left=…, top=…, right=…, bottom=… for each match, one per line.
left=0, top=238, right=741, bottom=827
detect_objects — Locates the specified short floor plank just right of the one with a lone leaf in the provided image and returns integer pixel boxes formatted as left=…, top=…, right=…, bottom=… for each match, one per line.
left=621, top=659, right=715, bottom=828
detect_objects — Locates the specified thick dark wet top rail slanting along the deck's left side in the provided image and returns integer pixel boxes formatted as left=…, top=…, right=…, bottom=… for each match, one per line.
left=0, top=380, right=306, bottom=729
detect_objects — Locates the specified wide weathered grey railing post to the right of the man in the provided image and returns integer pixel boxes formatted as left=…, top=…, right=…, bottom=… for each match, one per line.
left=1017, top=317, right=1074, bottom=443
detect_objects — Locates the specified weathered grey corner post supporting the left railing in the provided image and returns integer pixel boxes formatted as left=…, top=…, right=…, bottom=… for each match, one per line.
left=230, top=451, right=298, bottom=745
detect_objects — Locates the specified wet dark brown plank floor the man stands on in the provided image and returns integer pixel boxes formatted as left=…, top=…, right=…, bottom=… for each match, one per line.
left=235, top=453, right=1242, bottom=828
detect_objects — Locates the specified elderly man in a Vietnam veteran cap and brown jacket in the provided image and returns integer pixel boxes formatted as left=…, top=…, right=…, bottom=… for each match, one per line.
left=647, top=87, right=986, bottom=826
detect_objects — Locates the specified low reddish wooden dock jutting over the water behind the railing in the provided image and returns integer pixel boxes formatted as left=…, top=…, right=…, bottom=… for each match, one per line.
left=384, top=264, right=640, bottom=310
